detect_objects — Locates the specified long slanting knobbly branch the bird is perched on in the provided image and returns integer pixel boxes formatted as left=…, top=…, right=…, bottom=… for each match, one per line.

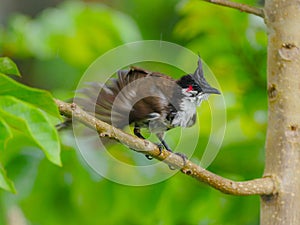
left=55, top=100, right=278, bottom=195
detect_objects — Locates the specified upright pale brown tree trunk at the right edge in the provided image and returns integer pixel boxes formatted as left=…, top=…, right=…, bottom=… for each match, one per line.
left=261, top=0, right=300, bottom=225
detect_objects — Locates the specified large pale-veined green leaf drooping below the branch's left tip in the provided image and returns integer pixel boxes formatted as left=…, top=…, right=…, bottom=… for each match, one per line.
left=0, top=96, right=61, bottom=166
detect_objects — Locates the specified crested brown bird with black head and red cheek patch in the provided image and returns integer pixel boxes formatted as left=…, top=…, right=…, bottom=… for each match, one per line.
left=76, top=57, right=221, bottom=158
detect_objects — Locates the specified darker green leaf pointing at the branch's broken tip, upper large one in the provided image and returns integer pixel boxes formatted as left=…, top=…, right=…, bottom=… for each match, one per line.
left=0, top=73, right=60, bottom=118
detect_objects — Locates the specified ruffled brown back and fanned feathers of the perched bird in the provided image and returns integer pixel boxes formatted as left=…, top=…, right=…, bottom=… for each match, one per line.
left=79, top=67, right=175, bottom=128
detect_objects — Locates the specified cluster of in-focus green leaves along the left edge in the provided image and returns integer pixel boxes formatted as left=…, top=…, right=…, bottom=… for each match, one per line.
left=0, top=58, right=61, bottom=192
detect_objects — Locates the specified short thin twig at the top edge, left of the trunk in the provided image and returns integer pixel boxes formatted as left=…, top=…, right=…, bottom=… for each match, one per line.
left=202, top=0, right=265, bottom=18
